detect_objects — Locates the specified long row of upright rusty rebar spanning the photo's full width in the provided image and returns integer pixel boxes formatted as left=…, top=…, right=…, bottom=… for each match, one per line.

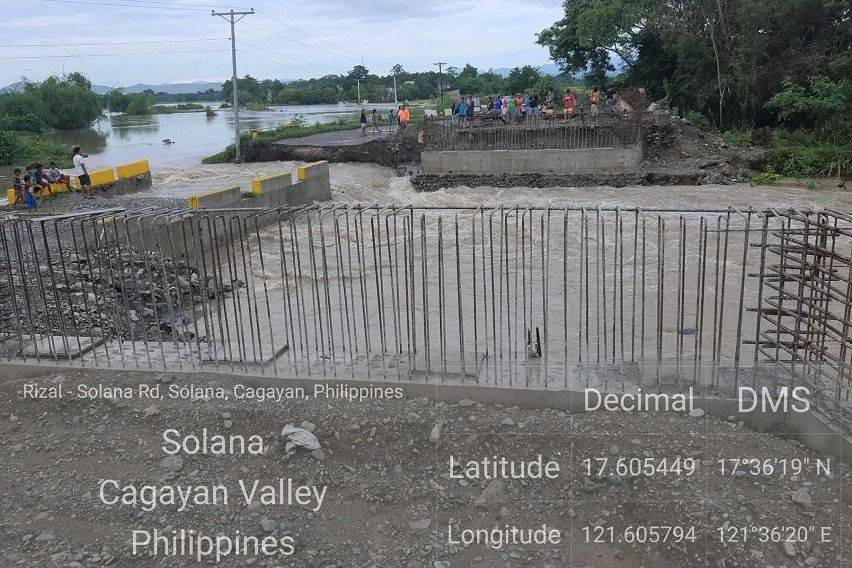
left=0, top=204, right=852, bottom=428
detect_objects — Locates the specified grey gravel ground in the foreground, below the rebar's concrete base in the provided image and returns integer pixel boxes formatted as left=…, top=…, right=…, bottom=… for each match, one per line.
left=0, top=371, right=852, bottom=568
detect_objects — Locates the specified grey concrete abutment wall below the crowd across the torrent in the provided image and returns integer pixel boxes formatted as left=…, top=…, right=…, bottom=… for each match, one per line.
left=421, top=145, right=642, bottom=174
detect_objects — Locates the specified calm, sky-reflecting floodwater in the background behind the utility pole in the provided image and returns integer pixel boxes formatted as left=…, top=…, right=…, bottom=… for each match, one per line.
left=0, top=102, right=400, bottom=188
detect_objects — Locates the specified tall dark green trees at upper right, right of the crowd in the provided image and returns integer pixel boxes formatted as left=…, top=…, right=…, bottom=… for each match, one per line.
left=538, top=0, right=852, bottom=126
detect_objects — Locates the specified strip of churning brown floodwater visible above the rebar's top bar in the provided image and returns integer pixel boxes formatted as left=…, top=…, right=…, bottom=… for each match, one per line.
left=146, top=162, right=852, bottom=211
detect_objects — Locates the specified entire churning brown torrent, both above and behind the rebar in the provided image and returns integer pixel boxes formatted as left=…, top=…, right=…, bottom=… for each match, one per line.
left=140, top=162, right=852, bottom=384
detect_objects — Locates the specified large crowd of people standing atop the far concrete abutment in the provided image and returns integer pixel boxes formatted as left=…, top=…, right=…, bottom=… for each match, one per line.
left=451, top=87, right=618, bottom=126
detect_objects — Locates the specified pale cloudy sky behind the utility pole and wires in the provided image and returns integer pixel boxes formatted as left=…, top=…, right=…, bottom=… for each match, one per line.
left=0, top=0, right=562, bottom=86
